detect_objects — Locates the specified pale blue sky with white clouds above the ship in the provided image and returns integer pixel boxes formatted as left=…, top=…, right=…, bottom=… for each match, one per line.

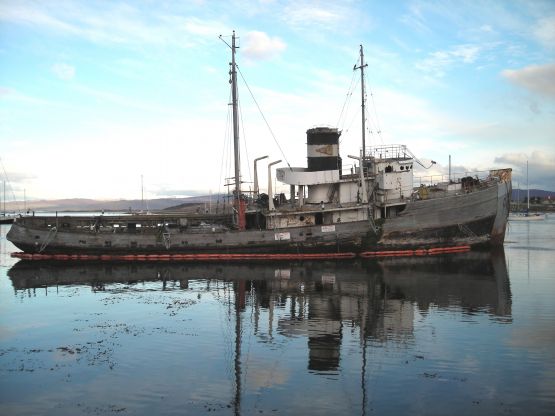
left=0, top=0, right=555, bottom=200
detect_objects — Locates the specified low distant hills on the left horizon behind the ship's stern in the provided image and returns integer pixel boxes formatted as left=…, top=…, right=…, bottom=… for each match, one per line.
left=6, top=195, right=226, bottom=212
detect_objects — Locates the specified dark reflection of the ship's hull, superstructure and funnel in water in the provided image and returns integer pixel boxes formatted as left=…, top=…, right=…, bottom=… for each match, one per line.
left=8, top=250, right=511, bottom=344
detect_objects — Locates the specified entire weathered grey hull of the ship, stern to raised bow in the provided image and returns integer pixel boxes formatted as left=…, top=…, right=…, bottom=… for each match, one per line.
left=7, top=182, right=509, bottom=254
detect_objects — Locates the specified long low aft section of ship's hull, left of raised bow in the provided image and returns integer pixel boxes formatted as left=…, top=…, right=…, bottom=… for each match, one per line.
left=7, top=221, right=370, bottom=254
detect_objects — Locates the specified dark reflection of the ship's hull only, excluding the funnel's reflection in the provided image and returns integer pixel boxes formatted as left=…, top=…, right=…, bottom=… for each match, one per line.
left=8, top=250, right=511, bottom=320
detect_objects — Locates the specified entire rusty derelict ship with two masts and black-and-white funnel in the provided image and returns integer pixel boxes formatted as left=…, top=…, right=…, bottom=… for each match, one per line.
left=7, top=33, right=511, bottom=255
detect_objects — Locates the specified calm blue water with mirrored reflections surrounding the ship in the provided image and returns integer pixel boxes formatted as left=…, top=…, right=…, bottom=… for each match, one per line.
left=0, top=216, right=555, bottom=415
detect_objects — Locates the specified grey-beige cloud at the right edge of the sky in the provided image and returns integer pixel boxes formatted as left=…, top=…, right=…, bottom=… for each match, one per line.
left=501, top=63, right=555, bottom=98
